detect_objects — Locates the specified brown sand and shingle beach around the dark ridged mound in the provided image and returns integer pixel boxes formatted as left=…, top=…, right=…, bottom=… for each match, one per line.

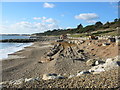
left=2, top=40, right=118, bottom=88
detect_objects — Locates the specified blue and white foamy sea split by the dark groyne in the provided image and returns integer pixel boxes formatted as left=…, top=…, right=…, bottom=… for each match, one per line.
left=0, top=35, right=32, bottom=60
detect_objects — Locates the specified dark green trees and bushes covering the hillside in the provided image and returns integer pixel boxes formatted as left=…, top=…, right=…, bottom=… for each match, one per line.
left=33, top=18, right=120, bottom=37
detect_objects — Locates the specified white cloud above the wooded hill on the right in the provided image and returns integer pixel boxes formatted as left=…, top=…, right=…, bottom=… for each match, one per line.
left=75, top=13, right=99, bottom=23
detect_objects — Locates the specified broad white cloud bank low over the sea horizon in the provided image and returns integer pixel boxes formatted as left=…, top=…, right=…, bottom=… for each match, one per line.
left=0, top=17, right=59, bottom=34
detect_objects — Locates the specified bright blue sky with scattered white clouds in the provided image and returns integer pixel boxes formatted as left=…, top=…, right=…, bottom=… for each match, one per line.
left=0, top=2, right=118, bottom=34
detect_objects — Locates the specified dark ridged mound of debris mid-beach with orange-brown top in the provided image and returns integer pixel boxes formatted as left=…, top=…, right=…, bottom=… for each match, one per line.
left=40, top=42, right=87, bottom=63
